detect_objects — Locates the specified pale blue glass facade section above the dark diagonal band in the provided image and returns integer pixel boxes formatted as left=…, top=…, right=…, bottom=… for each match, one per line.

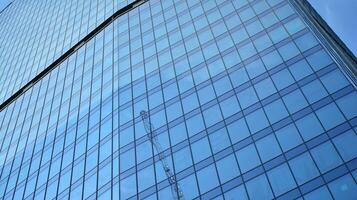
left=0, top=0, right=132, bottom=102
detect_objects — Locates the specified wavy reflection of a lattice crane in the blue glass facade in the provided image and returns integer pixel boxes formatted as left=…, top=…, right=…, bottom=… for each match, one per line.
left=140, top=110, right=184, bottom=200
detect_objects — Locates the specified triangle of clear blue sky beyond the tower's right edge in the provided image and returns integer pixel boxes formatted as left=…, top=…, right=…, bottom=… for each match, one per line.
left=308, top=0, right=357, bottom=56
